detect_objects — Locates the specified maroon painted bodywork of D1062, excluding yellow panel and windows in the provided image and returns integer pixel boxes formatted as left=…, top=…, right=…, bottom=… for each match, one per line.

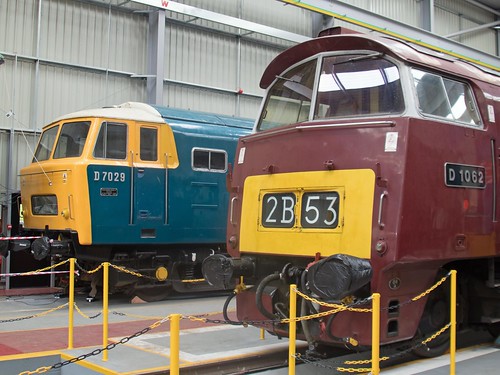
left=227, top=31, right=500, bottom=345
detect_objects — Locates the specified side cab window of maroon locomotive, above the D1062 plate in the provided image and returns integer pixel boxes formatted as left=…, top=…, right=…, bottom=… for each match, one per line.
left=412, top=69, right=481, bottom=127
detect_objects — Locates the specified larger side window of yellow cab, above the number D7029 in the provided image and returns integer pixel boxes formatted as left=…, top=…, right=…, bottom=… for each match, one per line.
left=94, top=122, right=127, bottom=160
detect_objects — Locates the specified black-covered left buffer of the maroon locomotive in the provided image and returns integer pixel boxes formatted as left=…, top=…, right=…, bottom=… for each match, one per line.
left=201, top=254, right=255, bottom=289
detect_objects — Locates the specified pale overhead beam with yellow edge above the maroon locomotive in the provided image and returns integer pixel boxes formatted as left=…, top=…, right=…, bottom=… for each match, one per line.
left=278, top=0, right=500, bottom=71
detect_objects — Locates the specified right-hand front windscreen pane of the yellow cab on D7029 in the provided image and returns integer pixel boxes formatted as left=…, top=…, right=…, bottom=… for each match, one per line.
left=54, top=121, right=90, bottom=159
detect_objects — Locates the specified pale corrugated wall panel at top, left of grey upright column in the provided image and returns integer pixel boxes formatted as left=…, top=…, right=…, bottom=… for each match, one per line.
left=40, top=0, right=148, bottom=72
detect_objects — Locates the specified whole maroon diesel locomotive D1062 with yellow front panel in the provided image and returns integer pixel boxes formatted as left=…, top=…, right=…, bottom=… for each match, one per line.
left=203, top=27, right=500, bottom=356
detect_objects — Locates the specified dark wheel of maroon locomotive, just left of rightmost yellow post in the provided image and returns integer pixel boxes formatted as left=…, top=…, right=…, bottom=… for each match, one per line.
left=413, top=276, right=450, bottom=358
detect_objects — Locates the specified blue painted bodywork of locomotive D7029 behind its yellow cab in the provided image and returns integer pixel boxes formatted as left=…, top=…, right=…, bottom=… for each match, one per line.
left=88, top=107, right=253, bottom=245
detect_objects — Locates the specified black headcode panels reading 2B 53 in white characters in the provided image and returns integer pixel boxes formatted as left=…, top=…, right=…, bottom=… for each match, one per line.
left=262, top=191, right=339, bottom=229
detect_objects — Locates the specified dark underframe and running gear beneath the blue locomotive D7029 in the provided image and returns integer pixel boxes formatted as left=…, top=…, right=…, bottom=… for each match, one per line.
left=28, top=230, right=225, bottom=300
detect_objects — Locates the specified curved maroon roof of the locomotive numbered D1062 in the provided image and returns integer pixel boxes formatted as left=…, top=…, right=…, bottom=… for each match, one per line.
left=260, top=34, right=500, bottom=89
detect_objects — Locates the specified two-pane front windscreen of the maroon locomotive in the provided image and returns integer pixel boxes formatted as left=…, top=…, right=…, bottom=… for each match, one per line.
left=257, top=53, right=404, bottom=131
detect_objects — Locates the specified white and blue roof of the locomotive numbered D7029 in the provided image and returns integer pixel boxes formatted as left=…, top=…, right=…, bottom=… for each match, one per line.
left=48, top=102, right=254, bottom=133
